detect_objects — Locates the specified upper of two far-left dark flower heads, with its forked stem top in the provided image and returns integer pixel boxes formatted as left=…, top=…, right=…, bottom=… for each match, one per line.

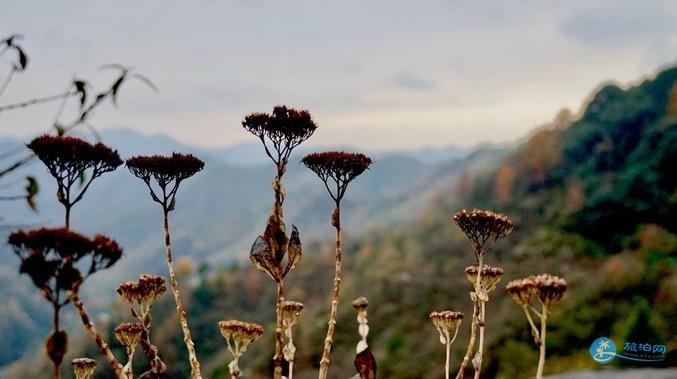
left=28, top=135, right=122, bottom=228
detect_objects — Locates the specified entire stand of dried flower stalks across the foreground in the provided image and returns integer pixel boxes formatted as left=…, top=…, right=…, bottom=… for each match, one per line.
left=8, top=106, right=567, bottom=379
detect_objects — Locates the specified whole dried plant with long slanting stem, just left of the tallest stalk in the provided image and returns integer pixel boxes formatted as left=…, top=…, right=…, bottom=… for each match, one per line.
left=127, top=153, right=204, bottom=379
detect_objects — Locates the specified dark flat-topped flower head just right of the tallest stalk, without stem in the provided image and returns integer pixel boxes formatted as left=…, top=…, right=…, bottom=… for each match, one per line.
left=301, top=151, right=372, bottom=202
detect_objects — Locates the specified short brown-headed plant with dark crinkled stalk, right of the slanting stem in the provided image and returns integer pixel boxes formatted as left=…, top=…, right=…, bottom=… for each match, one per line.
left=117, top=274, right=167, bottom=377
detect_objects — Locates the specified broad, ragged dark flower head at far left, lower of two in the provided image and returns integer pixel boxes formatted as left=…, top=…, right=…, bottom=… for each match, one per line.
left=8, top=228, right=122, bottom=296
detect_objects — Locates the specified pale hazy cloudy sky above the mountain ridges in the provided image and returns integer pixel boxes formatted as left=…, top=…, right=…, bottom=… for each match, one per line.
left=0, top=0, right=677, bottom=149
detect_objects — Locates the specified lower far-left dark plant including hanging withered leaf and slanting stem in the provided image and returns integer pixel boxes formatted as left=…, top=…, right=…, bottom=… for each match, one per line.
left=8, top=228, right=122, bottom=378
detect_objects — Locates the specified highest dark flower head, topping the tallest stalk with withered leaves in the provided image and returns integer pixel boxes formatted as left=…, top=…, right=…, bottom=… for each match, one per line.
left=242, top=105, right=317, bottom=166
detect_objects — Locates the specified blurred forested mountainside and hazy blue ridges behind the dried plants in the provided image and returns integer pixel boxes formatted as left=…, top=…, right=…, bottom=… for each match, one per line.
left=0, top=68, right=677, bottom=378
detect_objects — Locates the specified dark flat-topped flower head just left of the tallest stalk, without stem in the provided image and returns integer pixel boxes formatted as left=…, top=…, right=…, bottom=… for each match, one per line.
left=126, top=153, right=204, bottom=212
